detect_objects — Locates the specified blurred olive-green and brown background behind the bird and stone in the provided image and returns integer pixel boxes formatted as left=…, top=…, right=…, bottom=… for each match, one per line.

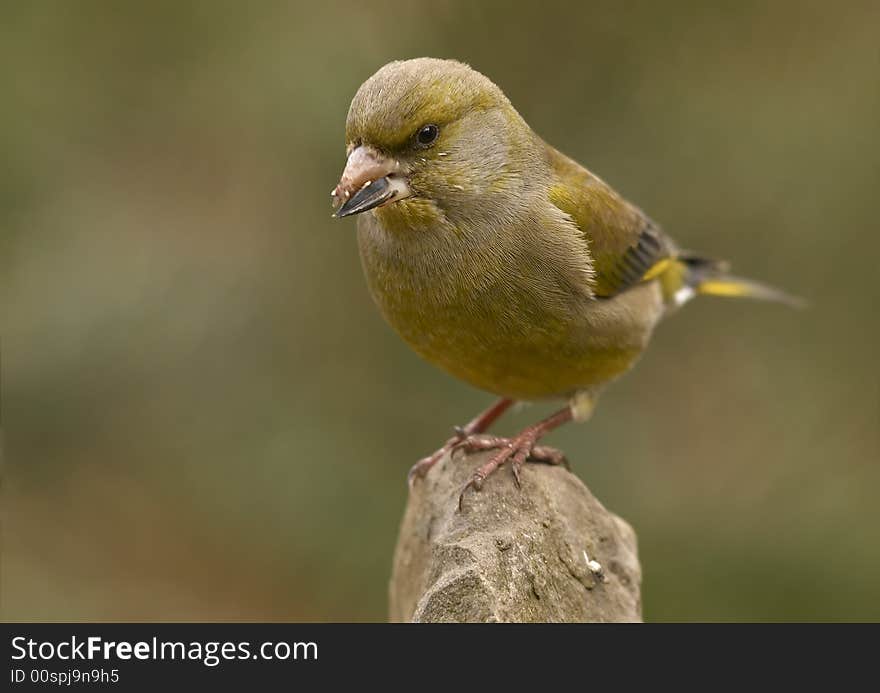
left=0, top=0, right=880, bottom=620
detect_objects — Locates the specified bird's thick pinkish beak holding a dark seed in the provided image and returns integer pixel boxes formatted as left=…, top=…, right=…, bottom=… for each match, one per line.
left=331, top=145, right=412, bottom=217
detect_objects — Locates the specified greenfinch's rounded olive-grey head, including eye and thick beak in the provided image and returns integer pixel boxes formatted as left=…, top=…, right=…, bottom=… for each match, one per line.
left=332, top=58, right=541, bottom=228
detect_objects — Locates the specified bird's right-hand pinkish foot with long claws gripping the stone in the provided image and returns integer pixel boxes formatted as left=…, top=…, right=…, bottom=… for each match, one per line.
left=452, top=427, right=570, bottom=510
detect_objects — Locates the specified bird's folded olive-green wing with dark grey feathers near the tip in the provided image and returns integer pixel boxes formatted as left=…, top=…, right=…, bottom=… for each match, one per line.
left=548, top=146, right=676, bottom=297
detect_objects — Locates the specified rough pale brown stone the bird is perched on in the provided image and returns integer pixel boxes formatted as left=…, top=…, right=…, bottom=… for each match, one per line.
left=390, top=452, right=642, bottom=623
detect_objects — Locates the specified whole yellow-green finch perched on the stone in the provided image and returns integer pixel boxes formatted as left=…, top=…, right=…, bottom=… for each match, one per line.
left=331, top=58, right=800, bottom=507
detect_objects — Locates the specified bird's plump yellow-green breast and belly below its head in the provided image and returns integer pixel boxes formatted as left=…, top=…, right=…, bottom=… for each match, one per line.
left=358, top=215, right=652, bottom=399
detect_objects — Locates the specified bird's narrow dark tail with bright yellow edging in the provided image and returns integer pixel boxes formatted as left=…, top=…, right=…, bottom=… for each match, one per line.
left=658, top=253, right=805, bottom=308
